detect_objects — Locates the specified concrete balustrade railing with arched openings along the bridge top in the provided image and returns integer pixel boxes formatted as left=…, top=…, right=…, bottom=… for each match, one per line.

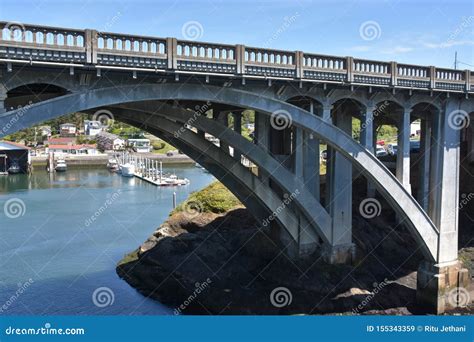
left=0, top=22, right=474, bottom=92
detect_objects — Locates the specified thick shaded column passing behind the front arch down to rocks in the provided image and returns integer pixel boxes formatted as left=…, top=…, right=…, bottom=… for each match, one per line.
left=323, top=111, right=355, bottom=264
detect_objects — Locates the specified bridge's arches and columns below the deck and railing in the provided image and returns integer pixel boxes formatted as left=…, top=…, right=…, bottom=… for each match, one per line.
left=0, top=73, right=474, bottom=312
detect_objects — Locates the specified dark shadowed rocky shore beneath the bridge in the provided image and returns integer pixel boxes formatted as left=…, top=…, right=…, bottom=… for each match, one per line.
left=116, top=182, right=474, bottom=315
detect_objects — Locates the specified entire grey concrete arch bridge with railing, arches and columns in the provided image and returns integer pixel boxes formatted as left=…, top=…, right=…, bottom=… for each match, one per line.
left=0, top=23, right=474, bottom=312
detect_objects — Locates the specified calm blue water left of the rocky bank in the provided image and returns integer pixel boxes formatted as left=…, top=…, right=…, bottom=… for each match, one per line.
left=0, top=167, right=213, bottom=315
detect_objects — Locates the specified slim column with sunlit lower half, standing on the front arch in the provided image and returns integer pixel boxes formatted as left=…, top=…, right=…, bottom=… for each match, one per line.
left=396, top=108, right=411, bottom=193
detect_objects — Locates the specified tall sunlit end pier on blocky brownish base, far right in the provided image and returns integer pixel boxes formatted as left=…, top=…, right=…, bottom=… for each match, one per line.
left=417, top=100, right=469, bottom=313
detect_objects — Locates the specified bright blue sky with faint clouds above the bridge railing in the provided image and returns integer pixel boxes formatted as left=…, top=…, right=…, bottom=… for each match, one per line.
left=0, top=0, right=474, bottom=70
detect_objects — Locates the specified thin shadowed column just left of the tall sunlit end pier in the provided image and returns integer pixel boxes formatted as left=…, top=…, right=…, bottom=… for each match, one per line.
left=418, top=116, right=431, bottom=212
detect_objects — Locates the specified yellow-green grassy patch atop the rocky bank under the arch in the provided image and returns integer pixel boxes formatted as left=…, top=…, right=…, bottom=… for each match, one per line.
left=171, top=181, right=242, bottom=214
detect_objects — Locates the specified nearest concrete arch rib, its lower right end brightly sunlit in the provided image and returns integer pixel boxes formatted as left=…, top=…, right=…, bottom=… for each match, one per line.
left=0, top=84, right=439, bottom=260
